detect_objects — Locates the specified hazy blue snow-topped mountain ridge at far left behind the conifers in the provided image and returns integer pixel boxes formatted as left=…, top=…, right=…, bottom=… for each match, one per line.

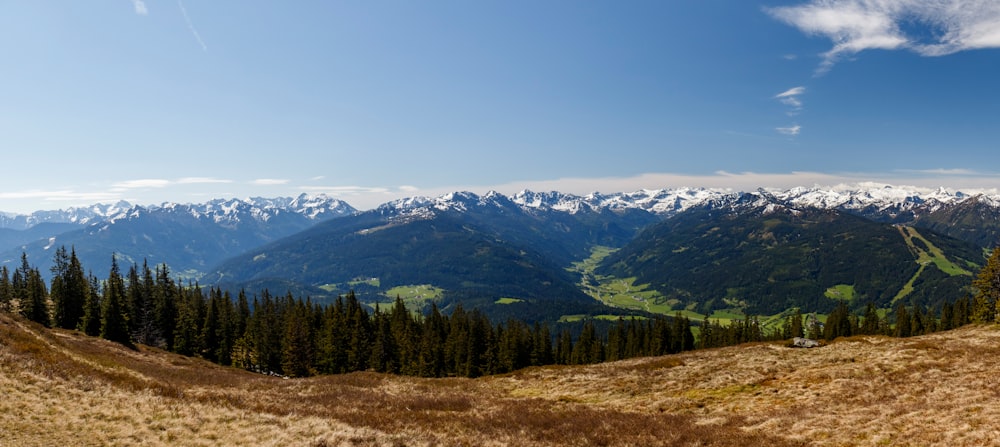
left=0, top=194, right=356, bottom=278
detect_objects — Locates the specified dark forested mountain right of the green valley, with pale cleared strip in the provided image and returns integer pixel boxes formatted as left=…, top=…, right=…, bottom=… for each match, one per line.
left=598, top=194, right=984, bottom=315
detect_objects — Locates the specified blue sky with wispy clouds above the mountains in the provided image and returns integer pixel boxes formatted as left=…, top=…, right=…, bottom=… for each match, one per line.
left=0, top=0, right=1000, bottom=212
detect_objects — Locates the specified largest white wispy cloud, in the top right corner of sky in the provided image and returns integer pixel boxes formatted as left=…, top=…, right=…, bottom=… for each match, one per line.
left=766, top=0, right=1000, bottom=73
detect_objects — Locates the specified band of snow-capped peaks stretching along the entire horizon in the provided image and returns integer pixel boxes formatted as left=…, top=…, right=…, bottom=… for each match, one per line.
left=0, top=183, right=1000, bottom=234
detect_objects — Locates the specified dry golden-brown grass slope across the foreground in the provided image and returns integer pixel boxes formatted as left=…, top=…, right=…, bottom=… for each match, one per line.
left=0, top=315, right=1000, bottom=447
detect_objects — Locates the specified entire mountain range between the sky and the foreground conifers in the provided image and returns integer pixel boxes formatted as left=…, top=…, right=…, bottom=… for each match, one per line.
left=0, top=184, right=1000, bottom=320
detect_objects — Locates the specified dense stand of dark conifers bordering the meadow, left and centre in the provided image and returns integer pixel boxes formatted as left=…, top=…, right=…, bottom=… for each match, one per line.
left=0, top=247, right=695, bottom=377
